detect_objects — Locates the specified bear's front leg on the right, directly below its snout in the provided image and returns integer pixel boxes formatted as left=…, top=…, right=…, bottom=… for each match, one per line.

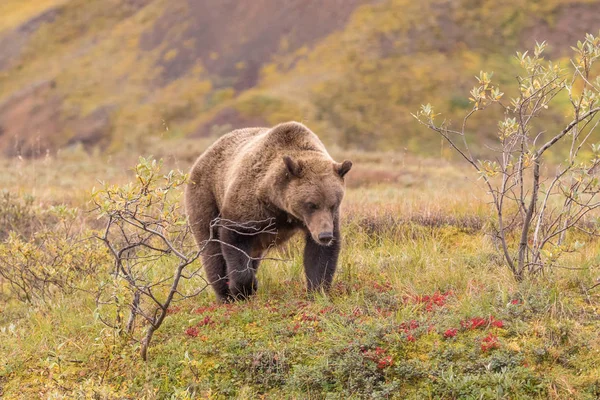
left=304, top=221, right=341, bottom=292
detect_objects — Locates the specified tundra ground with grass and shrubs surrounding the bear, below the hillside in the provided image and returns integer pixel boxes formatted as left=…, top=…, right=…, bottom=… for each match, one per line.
left=0, top=36, right=600, bottom=399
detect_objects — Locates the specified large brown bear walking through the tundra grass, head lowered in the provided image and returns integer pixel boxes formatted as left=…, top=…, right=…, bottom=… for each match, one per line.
left=185, top=122, right=352, bottom=302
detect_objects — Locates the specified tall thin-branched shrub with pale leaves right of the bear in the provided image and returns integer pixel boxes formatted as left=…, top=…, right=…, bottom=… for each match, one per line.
left=414, top=35, right=600, bottom=280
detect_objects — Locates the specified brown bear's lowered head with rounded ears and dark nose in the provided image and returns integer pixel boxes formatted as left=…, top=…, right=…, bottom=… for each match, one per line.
left=283, top=156, right=352, bottom=246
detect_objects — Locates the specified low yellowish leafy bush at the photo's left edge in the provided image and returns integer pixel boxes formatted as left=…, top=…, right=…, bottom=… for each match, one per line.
left=0, top=193, right=108, bottom=302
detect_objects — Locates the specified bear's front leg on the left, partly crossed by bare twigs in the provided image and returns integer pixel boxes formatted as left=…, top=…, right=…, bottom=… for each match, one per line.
left=219, top=228, right=258, bottom=300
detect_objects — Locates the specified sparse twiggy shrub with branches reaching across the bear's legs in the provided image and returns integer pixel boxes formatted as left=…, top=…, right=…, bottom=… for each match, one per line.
left=93, top=158, right=271, bottom=360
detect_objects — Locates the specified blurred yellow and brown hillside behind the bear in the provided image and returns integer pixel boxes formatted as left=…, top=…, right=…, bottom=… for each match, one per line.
left=0, top=0, right=600, bottom=156
